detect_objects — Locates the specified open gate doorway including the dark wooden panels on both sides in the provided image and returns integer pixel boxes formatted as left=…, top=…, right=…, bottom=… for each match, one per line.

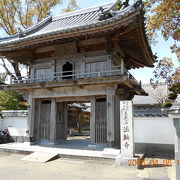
left=33, top=98, right=107, bottom=147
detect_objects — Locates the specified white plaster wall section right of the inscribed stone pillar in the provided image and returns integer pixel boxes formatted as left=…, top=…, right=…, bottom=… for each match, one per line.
left=134, top=117, right=175, bottom=144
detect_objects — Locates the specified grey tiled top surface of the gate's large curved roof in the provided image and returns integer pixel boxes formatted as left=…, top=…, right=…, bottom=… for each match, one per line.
left=0, top=0, right=142, bottom=46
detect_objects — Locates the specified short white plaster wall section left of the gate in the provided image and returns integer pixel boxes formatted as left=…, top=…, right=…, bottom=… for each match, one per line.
left=0, top=117, right=27, bottom=136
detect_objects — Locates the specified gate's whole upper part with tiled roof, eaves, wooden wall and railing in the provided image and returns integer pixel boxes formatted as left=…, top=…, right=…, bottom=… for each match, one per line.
left=0, top=1, right=154, bottom=93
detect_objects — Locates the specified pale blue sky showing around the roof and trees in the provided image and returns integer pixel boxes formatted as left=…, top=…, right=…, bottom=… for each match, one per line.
left=0, top=0, right=179, bottom=83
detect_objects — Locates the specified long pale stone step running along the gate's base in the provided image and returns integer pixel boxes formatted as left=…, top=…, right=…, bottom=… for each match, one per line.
left=0, top=143, right=117, bottom=161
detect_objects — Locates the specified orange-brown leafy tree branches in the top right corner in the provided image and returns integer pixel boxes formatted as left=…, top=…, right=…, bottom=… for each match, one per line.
left=144, top=0, right=180, bottom=50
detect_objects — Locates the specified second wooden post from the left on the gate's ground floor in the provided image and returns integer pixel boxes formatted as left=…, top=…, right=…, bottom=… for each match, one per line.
left=50, top=99, right=57, bottom=142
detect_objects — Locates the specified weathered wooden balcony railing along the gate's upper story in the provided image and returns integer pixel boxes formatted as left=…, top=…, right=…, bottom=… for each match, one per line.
left=10, top=66, right=139, bottom=84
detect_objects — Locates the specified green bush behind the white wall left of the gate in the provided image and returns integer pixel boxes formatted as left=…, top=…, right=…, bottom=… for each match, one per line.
left=0, top=90, right=27, bottom=111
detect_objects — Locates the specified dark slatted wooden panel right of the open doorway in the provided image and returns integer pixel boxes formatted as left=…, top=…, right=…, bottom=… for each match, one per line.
left=95, top=98, right=107, bottom=144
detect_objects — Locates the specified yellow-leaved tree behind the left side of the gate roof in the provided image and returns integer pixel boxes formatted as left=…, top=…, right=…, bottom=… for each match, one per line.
left=0, top=0, right=77, bottom=77
